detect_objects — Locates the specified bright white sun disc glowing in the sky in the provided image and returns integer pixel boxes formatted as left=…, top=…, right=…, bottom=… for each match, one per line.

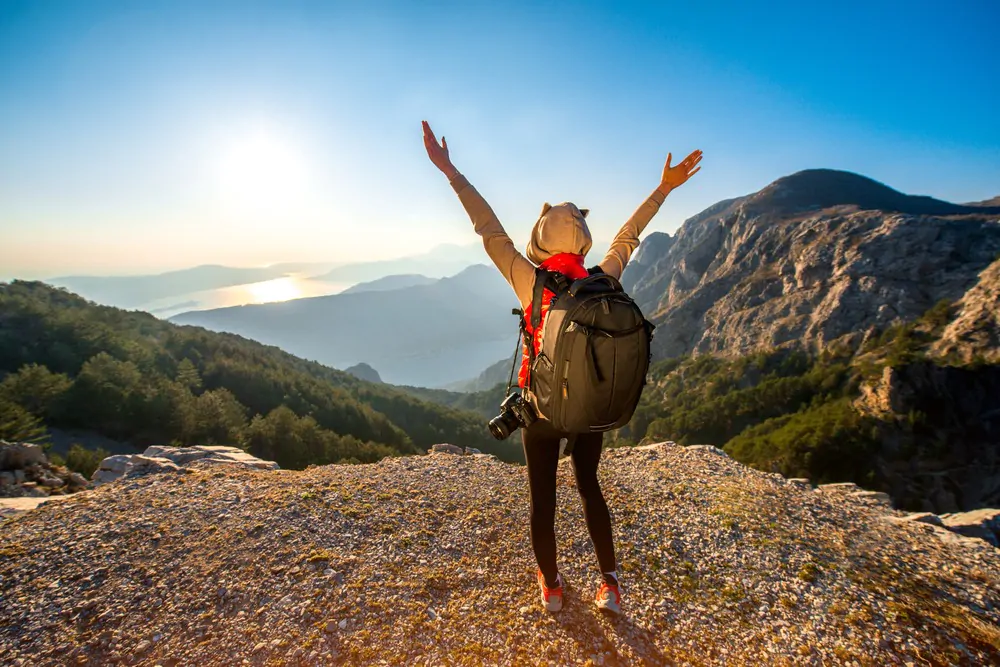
left=217, top=128, right=307, bottom=214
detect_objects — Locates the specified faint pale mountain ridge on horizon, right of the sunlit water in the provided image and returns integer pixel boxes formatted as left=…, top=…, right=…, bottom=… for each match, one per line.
left=316, top=242, right=487, bottom=283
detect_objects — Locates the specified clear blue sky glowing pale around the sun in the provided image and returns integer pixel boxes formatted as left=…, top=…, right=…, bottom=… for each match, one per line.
left=0, top=0, right=1000, bottom=279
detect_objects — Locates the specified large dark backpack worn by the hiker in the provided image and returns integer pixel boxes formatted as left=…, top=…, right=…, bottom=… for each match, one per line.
left=522, top=267, right=654, bottom=433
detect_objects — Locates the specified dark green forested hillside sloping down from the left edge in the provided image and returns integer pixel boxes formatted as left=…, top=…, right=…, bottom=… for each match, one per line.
left=0, top=281, right=510, bottom=467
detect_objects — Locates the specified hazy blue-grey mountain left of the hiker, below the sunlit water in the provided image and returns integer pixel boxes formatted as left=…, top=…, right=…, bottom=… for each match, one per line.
left=171, top=265, right=517, bottom=387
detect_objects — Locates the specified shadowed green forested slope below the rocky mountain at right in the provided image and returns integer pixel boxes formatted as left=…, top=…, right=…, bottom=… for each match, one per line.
left=611, top=302, right=1000, bottom=511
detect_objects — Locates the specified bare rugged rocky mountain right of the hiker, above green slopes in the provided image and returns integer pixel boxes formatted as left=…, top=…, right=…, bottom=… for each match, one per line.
left=623, top=169, right=1000, bottom=358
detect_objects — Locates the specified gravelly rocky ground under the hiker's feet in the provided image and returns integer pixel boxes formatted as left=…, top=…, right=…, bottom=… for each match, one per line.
left=0, top=445, right=1000, bottom=667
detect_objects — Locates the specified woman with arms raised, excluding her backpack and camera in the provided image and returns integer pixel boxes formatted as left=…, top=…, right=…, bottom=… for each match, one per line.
left=423, top=121, right=701, bottom=614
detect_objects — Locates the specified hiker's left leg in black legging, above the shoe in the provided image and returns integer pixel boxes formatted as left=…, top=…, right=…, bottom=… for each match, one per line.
left=521, top=420, right=560, bottom=586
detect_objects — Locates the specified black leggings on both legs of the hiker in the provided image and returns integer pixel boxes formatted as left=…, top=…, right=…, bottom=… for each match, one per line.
left=521, top=419, right=617, bottom=583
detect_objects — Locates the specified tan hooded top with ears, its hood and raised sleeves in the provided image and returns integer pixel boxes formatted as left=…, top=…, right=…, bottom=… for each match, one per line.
left=451, top=174, right=665, bottom=308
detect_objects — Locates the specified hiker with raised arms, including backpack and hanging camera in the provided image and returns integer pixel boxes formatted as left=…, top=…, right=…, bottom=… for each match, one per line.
left=423, top=121, right=702, bottom=614
